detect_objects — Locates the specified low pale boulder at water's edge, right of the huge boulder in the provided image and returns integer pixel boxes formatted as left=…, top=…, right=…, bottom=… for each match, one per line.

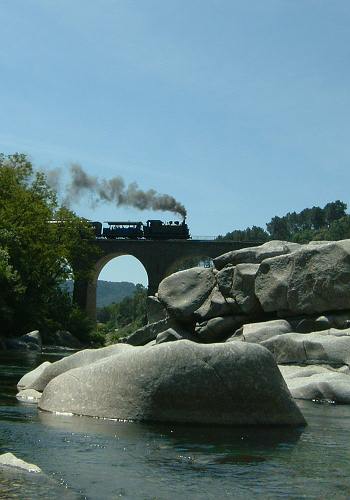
left=279, top=365, right=350, bottom=404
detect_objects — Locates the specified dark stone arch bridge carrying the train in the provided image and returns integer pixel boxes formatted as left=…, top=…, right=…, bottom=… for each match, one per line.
left=74, top=239, right=259, bottom=320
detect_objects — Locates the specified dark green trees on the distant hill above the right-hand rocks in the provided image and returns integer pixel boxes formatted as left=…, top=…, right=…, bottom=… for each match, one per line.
left=217, top=200, right=350, bottom=243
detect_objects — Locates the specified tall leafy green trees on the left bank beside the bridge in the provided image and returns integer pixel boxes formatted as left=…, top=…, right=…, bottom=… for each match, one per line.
left=0, top=154, right=96, bottom=336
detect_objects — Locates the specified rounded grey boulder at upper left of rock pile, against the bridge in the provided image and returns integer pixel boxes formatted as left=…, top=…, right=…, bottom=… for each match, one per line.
left=158, top=267, right=215, bottom=321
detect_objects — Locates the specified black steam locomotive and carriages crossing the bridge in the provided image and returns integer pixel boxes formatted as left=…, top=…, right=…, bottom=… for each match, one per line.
left=92, top=220, right=190, bottom=240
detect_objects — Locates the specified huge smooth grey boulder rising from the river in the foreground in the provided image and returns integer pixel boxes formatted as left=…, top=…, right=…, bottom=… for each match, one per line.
left=39, top=340, right=305, bottom=425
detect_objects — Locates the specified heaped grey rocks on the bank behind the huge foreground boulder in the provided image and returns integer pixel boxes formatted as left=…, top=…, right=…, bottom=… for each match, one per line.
left=125, top=236, right=350, bottom=403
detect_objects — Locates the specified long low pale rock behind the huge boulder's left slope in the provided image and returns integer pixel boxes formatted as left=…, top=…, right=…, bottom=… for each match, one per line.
left=26, top=344, right=132, bottom=391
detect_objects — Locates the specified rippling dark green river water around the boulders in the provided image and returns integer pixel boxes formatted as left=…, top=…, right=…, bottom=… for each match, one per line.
left=0, top=352, right=350, bottom=500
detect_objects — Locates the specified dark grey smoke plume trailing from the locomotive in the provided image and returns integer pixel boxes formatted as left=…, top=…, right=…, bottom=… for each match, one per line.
left=59, top=163, right=187, bottom=218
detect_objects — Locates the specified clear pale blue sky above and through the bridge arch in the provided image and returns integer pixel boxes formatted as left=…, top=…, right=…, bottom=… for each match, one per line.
left=0, top=0, right=350, bottom=283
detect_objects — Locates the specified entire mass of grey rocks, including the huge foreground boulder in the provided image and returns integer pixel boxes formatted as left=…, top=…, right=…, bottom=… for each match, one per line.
left=17, top=240, right=350, bottom=425
